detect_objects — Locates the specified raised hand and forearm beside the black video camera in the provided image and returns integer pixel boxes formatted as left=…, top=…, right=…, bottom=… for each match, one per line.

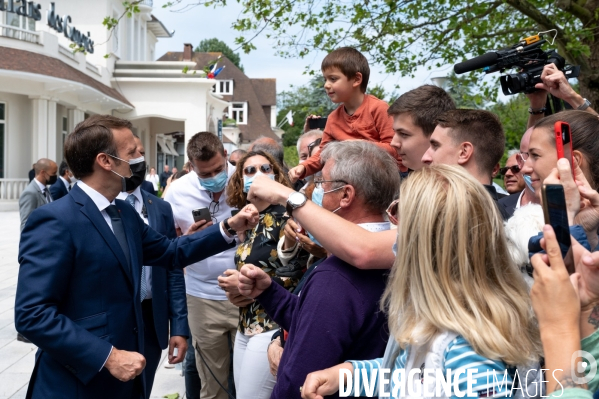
left=526, top=64, right=597, bottom=128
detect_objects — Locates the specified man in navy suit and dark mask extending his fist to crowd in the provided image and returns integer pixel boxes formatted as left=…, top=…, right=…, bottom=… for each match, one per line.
left=15, top=115, right=258, bottom=399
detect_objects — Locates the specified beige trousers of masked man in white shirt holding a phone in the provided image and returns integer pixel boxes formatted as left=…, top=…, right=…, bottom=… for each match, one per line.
left=187, top=295, right=239, bottom=399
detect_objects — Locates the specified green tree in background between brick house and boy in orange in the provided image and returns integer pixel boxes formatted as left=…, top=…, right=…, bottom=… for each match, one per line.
left=277, top=75, right=337, bottom=146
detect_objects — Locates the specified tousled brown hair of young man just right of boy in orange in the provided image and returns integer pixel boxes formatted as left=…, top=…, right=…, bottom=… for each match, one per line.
left=387, top=85, right=455, bottom=137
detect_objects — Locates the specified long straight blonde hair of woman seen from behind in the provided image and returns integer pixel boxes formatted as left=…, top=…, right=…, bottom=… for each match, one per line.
left=381, top=165, right=542, bottom=365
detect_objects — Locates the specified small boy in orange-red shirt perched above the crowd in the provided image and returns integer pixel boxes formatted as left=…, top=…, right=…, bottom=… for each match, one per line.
left=289, top=47, right=407, bottom=182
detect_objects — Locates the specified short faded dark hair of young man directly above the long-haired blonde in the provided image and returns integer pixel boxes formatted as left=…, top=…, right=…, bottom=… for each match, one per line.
left=437, top=109, right=505, bottom=176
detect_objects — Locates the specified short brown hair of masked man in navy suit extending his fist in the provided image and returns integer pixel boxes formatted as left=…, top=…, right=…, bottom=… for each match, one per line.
left=64, top=115, right=133, bottom=179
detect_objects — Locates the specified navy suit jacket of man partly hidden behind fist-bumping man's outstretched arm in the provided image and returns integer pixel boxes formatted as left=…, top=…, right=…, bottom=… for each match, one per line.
left=141, top=189, right=190, bottom=349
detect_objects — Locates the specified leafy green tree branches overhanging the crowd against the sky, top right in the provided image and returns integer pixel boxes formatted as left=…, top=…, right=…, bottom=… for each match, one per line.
left=166, top=0, right=599, bottom=104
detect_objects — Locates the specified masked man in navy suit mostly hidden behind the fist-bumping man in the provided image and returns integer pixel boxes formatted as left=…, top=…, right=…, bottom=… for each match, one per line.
left=117, top=136, right=190, bottom=396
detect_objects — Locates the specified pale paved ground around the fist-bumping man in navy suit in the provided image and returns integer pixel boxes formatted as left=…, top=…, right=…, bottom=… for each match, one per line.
left=0, top=212, right=185, bottom=399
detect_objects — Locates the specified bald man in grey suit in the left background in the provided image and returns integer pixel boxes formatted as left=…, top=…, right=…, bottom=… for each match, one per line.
left=19, top=158, right=58, bottom=231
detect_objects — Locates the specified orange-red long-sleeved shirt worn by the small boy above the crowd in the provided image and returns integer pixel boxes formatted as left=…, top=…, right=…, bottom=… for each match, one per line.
left=301, top=94, right=407, bottom=179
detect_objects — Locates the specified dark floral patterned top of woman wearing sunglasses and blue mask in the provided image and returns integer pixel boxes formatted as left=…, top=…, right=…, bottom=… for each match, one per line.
left=235, top=205, right=298, bottom=335
